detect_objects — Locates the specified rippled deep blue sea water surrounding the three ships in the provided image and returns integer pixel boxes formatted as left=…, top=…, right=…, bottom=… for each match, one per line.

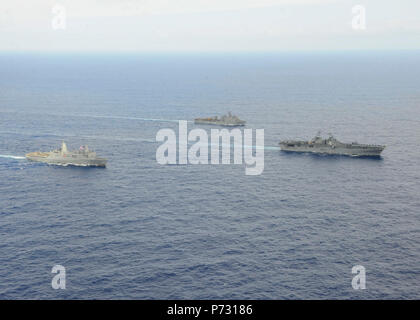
left=0, top=52, right=420, bottom=299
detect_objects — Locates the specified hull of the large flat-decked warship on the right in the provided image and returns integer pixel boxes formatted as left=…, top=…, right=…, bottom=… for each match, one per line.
left=280, top=144, right=384, bottom=157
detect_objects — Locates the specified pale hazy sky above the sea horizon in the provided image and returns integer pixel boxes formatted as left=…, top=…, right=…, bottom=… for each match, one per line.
left=0, top=0, right=420, bottom=51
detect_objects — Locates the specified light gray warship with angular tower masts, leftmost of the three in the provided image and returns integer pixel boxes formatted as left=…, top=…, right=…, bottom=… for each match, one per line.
left=26, top=141, right=107, bottom=167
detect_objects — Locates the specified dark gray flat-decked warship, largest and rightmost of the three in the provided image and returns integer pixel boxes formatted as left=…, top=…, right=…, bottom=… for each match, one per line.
left=279, top=132, right=385, bottom=157
